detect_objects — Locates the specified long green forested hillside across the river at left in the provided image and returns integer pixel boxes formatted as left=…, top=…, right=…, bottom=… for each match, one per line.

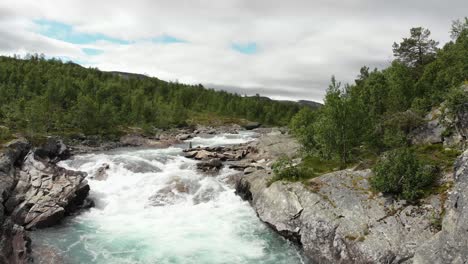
left=0, top=55, right=301, bottom=137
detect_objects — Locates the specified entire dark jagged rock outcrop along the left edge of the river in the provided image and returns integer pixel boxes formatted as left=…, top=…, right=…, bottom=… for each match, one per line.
left=0, top=137, right=89, bottom=263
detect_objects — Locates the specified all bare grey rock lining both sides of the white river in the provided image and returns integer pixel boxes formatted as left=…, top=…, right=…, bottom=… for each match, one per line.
left=0, top=127, right=468, bottom=263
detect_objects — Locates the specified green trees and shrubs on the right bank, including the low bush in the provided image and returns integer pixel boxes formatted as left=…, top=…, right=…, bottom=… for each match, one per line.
left=274, top=18, right=468, bottom=201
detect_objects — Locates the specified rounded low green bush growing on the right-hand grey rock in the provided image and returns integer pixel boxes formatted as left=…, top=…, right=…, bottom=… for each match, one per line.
left=370, top=148, right=437, bottom=201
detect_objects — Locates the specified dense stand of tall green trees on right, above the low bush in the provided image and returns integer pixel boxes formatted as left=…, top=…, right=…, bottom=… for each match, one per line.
left=290, top=19, right=468, bottom=171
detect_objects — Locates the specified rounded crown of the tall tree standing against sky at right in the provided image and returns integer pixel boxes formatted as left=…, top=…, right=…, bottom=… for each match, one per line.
left=393, top=27, right=439, bottom=68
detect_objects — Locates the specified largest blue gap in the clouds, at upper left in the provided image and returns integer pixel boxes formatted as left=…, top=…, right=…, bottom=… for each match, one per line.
left=34, top=19, right=130, bottom=45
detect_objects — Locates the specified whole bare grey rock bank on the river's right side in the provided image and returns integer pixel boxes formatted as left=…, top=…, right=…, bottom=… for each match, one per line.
left=188, top=132, right=468, bottom=263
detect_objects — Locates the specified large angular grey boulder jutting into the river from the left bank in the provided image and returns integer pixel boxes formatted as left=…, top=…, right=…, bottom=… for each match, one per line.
left=7, top=153, right=89, bottom=229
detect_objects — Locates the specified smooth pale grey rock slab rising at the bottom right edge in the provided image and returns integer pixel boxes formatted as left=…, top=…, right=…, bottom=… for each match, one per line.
left=414, top=151, right=468, bottom=264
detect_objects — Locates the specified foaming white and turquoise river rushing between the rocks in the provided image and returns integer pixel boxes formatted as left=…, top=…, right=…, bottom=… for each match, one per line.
left=33, top=132, right=302, bottom=264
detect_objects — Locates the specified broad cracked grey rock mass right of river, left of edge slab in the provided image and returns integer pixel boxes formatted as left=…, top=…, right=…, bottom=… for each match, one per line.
left=224, top=133, right=460, bottom=263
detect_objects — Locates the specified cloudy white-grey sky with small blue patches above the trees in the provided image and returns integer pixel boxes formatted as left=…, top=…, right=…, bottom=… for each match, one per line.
left=0, top=0, right=468, bottom=102
